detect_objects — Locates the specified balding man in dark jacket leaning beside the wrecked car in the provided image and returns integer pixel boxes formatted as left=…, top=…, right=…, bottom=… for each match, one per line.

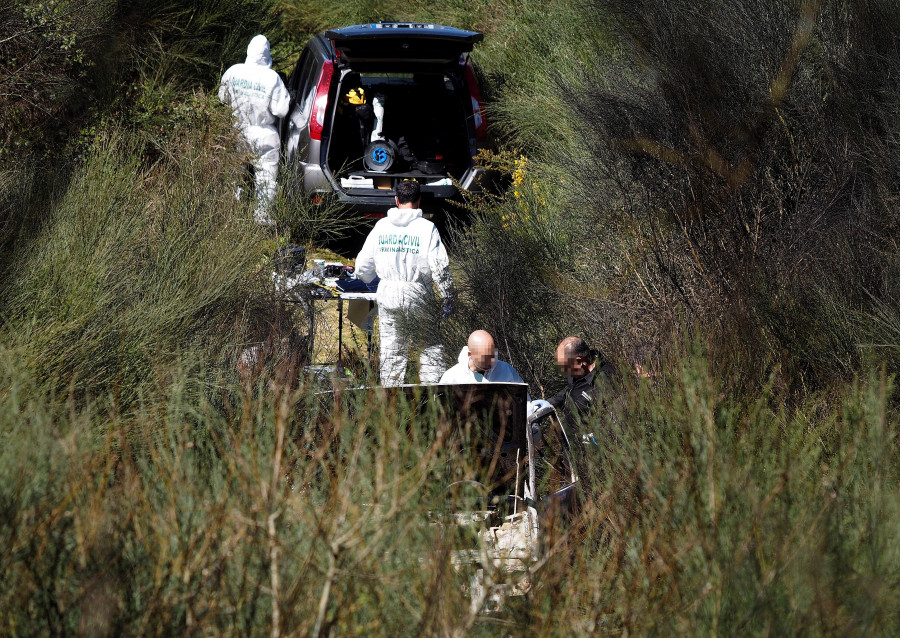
left=548, top=337, right=615, bottom=434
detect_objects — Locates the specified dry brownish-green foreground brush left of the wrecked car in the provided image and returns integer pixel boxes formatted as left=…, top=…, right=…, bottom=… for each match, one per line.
left=0, top=370, right=478, bottom=635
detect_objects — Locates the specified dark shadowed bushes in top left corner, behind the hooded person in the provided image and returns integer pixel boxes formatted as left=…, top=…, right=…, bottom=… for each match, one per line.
left=0, top=0, right=277, bottom=166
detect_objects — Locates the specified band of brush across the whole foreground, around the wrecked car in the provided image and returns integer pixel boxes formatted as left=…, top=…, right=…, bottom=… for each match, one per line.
left=0, top=344, right=900, bottom=636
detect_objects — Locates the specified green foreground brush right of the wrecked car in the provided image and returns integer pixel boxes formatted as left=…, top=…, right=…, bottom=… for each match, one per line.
left=520, top=358, right=900, bottom=635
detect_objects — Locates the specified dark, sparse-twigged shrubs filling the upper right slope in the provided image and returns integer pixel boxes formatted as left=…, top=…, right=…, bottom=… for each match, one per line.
left=486, top=1, right=900, bottom=390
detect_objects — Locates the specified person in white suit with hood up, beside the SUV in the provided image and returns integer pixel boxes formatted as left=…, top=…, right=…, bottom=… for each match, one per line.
left=219, top=35, right=291, bottom=226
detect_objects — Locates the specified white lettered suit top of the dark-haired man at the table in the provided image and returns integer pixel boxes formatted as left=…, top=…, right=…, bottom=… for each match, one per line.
left=356, top=208, right=453, bottom=309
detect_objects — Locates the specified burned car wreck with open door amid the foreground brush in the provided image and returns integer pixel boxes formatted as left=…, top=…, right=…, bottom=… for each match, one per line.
left=318, top=383, right=578, bottom=613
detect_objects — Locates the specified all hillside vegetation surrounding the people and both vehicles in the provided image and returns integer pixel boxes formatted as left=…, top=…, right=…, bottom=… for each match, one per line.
left=0, top=0, right=900, bottom=636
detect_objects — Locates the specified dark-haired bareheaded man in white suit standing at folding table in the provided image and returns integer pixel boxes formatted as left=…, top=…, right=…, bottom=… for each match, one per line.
left=356, top=181, right=453, bottom=386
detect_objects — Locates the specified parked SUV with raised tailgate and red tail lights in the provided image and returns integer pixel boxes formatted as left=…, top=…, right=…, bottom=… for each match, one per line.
left=282, top=22, right=487, bottom=216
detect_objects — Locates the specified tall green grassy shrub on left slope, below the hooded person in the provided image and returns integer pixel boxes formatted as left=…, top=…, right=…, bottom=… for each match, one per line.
left=3, top=97, right=274, bottom=398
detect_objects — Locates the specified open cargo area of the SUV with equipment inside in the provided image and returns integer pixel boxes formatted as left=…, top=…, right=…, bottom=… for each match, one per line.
left=327, top=71, right=473, bottom=196
